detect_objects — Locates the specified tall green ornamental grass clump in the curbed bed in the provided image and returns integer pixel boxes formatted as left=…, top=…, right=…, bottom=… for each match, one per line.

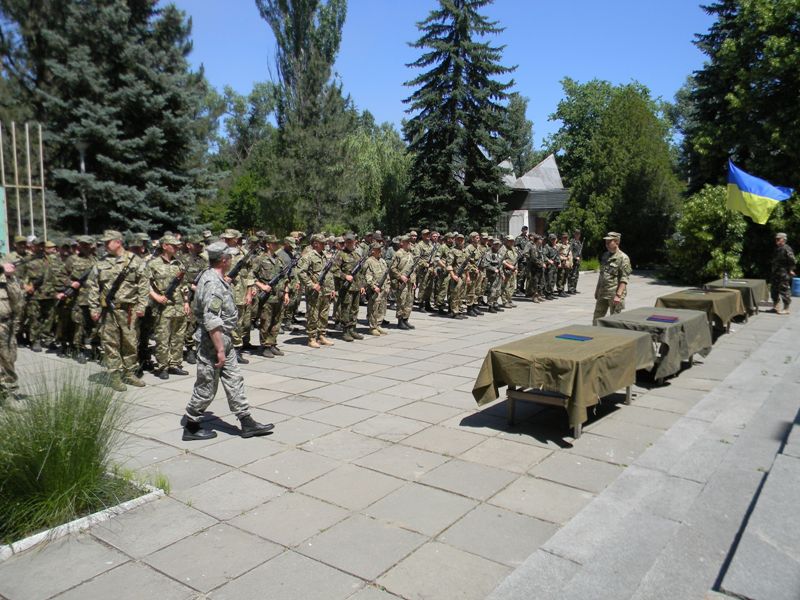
left=0, top=371, right=135, bottom=543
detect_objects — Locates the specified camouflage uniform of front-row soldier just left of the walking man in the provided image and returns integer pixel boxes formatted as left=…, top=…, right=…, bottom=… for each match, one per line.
left=146, top=248, right=189, bottom=372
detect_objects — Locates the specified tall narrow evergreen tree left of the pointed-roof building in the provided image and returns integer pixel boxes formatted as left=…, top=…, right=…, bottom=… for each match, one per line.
left=404, top=0, right=516, bottom=228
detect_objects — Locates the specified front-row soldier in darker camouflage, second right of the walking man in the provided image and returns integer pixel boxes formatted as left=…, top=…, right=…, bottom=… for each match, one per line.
left=253, top=235, right=291, bottom=358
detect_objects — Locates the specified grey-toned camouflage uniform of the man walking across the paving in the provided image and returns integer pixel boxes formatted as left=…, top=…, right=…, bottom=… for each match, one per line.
left=186, top=269, right=250, bottom=423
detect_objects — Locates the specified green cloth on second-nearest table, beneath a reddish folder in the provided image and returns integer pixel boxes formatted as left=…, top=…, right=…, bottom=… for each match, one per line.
left=597, top=307, right=712, bottom=379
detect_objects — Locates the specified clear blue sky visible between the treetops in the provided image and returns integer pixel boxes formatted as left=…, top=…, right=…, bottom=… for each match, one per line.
left=169, top=0, right=712, bottom=146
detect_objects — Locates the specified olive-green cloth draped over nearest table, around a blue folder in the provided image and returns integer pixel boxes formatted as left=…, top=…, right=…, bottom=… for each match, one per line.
left=472, top=325, right=655, bottom=427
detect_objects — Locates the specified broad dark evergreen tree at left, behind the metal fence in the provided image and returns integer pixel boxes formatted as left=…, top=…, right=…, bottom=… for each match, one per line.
left=2, top=0, right=213, bottom=231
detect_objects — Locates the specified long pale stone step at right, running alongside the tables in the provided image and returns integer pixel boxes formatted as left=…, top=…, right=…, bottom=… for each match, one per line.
left=490, top=316, right=800, bottom=600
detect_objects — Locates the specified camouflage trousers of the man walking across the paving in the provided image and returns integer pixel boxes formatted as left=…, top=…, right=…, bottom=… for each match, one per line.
left=186, top=332, right=250, bottom=423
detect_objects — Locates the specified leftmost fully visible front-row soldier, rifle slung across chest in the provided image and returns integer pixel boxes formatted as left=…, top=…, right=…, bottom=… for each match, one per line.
left=86, top=230, right=149, bottom=391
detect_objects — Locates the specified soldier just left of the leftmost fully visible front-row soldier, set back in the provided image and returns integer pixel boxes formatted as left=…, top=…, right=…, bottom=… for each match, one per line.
left=65, top=235, right=98, bottom=364
